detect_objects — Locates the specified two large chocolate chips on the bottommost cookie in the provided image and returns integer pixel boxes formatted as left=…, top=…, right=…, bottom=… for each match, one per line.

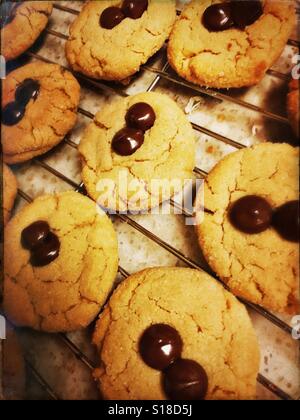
left=139, top=324, right=208, bottom=400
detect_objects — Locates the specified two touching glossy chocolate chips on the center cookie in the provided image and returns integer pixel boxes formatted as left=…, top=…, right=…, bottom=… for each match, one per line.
left=112, top=102, right=156, bottom=156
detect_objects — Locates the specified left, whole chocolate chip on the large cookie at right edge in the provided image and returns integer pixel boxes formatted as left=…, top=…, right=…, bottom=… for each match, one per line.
left=229, top=195, right=272, bottom=234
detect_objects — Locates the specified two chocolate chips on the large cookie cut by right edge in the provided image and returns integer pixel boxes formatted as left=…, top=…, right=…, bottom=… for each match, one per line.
left=229, top=195, right=299, bottom=242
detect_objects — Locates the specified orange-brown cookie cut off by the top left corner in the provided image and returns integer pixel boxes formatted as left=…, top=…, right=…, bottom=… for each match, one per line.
left=1, top=1, right=53, bottom=60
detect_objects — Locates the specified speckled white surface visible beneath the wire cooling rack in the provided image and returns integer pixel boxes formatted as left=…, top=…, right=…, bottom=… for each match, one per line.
left=2, top=1, right=300, bottom=399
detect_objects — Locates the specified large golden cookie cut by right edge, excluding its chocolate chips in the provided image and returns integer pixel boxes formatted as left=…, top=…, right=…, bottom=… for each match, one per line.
left=196, top=143, right=299, bottom=312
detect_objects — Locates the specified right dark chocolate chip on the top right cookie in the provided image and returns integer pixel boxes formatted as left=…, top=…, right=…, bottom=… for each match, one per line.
left=231, top=0, right=263, bottom=29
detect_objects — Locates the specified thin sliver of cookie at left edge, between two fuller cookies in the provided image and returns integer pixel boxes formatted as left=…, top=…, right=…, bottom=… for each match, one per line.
left=2, top=164, right=18, bottom=226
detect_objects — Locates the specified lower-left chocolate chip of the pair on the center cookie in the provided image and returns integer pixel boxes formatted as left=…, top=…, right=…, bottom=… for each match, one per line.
left=112, top=127, right=144, bottom=156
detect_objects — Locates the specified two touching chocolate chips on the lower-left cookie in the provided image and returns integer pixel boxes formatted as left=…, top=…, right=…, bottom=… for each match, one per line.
left=21, top=220, right=60, bottom=267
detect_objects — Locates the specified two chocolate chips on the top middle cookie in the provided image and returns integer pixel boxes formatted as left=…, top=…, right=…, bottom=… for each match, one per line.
left=99, top=0, right=148, bottom=29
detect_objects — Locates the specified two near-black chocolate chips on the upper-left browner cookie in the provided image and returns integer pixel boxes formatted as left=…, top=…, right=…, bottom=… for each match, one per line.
left=2, top=79, right=40, bottom=126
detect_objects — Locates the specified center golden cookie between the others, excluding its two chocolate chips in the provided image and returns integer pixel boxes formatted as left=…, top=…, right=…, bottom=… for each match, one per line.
left=79, top=92, right=195, bottom=211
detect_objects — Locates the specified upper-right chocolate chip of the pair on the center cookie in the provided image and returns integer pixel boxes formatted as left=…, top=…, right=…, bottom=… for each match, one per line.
left=126, top=102, right=156, bottom=131
